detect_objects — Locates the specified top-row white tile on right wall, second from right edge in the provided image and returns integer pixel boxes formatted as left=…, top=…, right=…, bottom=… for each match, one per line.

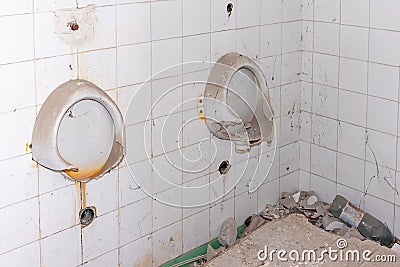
left=341, top=0, right=370, bottom=27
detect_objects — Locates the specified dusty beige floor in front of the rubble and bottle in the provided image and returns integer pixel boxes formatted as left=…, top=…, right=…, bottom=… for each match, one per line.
left=205, top=214, right=400, bottom=267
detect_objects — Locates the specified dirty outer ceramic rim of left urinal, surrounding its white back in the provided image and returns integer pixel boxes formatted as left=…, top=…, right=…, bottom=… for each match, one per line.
left=32, top=79, right=126, bottom=182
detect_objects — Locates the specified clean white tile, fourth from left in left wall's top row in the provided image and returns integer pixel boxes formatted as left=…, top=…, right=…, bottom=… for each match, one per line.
left=117, top=3, right=150, bottom=45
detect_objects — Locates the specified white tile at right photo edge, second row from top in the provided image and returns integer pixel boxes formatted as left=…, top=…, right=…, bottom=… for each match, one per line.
left=369, top=29, right=400, bottom=66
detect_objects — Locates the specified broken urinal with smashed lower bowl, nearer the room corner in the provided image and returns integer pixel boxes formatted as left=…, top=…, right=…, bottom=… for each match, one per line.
left=199, top=53, right=274, bottom=153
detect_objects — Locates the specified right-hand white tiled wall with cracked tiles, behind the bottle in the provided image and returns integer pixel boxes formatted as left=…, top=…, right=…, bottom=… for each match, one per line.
left=300, top=0, right=400, bottom=239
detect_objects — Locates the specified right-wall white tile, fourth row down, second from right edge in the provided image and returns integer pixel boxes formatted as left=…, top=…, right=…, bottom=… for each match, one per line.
left=338, top=90, right=367, bottom=126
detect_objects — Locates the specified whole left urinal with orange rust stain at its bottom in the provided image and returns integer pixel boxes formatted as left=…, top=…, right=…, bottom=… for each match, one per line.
left=32, top=79, right=125, bottom=182
